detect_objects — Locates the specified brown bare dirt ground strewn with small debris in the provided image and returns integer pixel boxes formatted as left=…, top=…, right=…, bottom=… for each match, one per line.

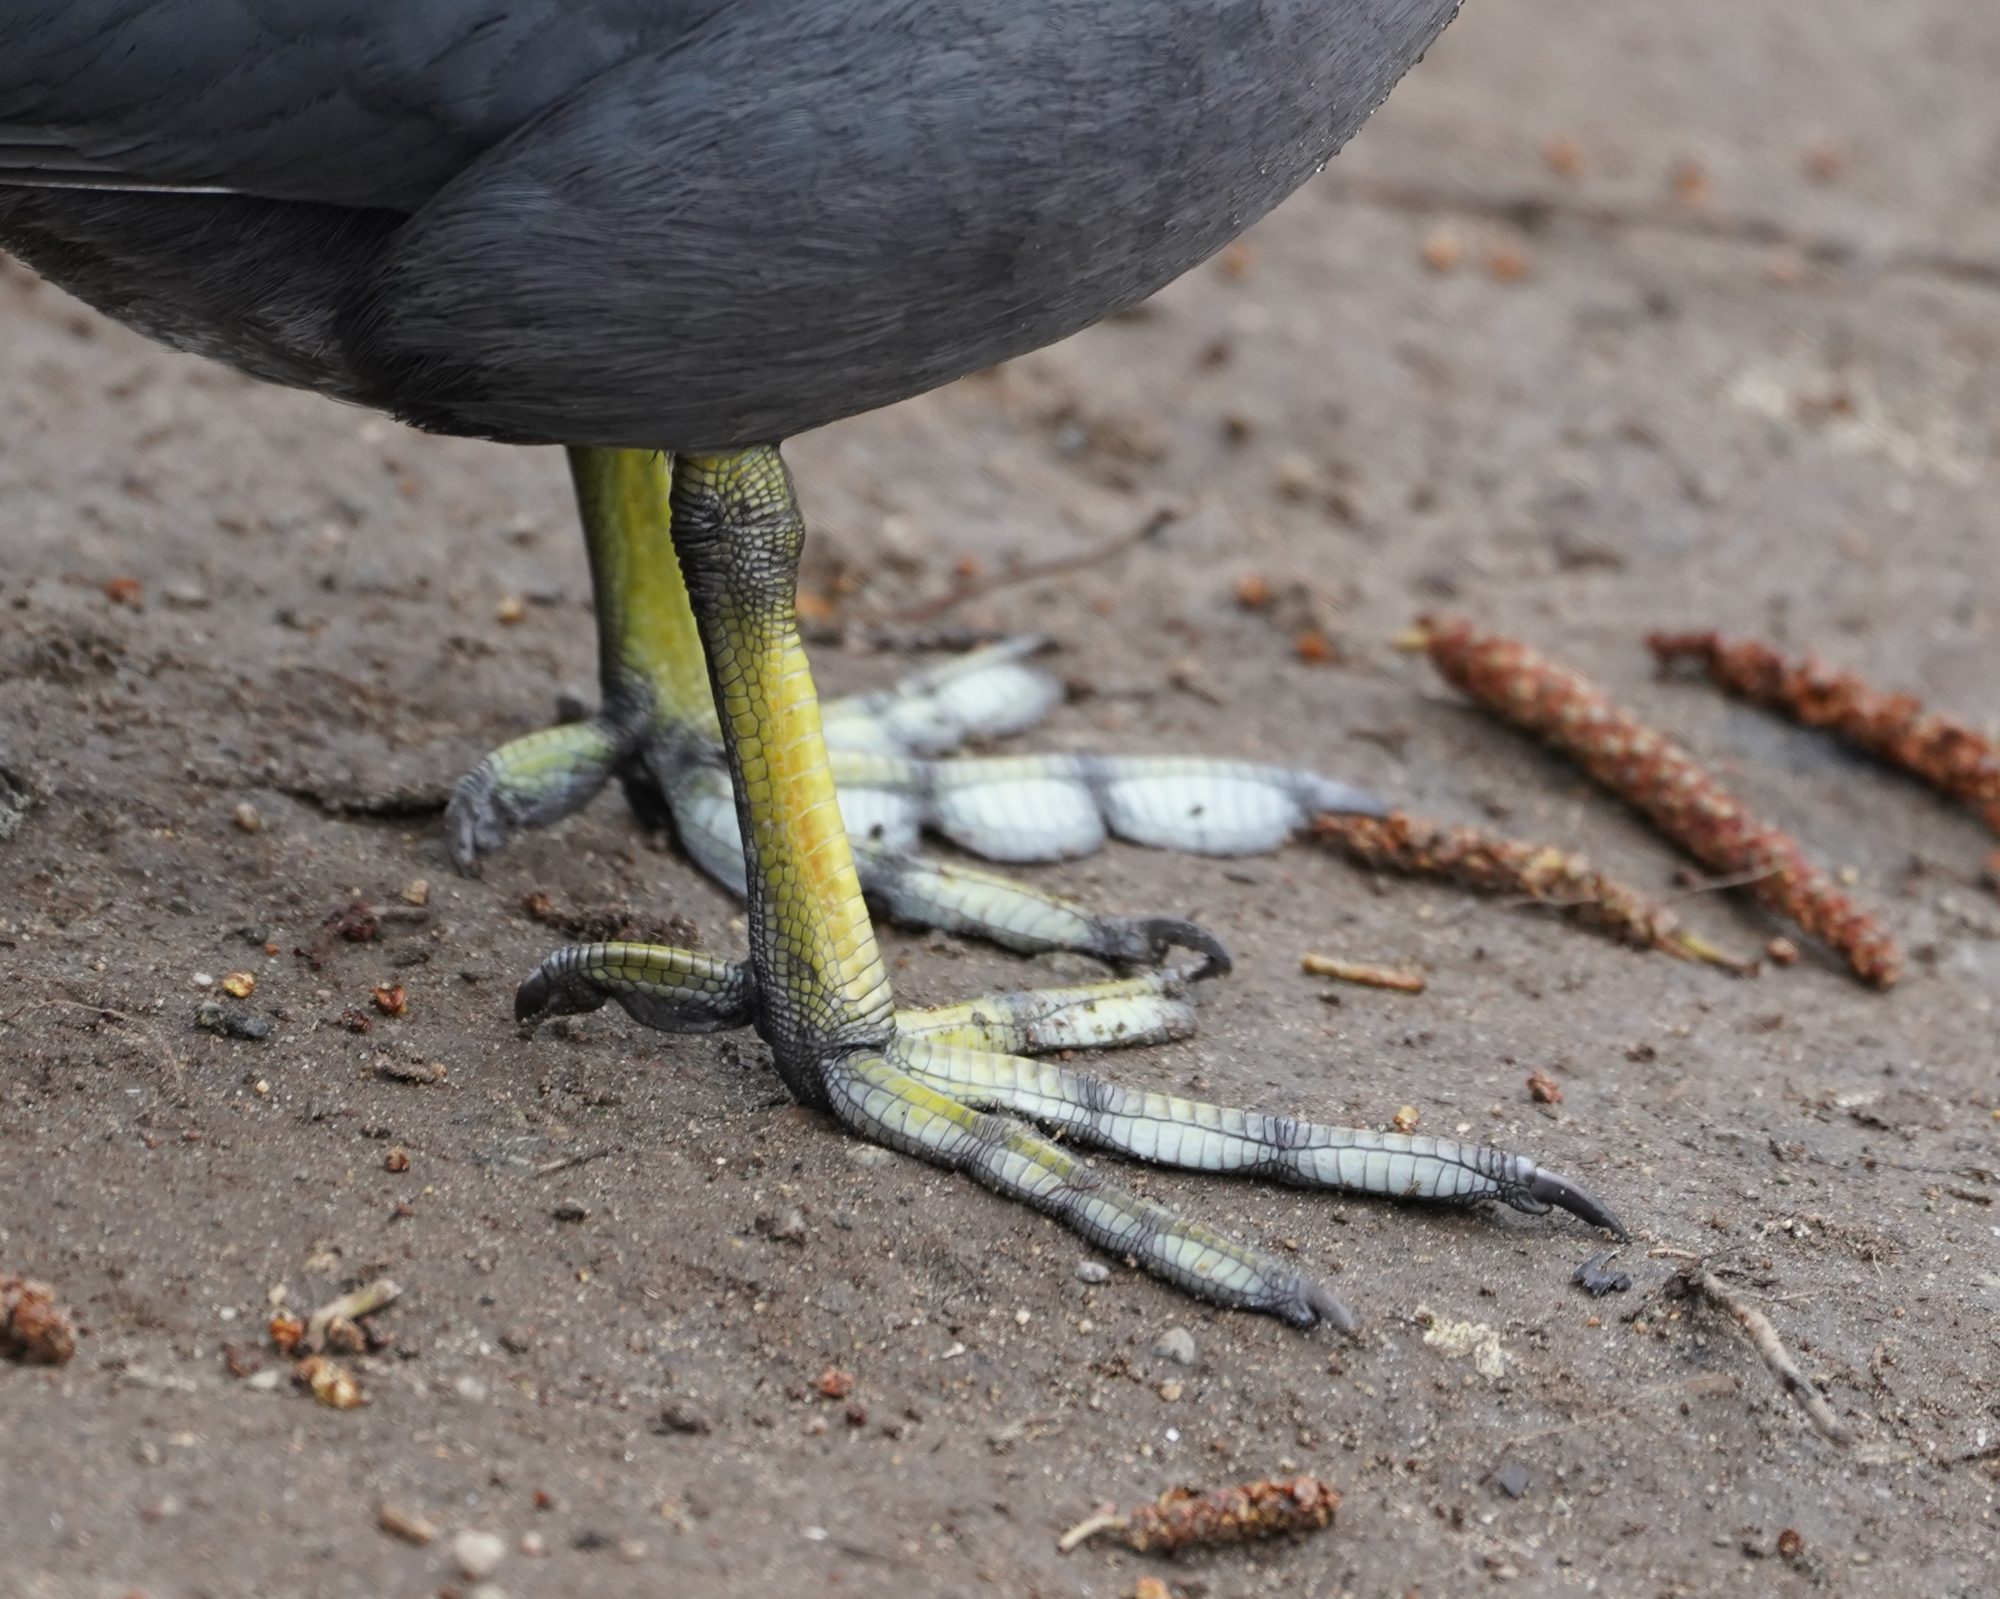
left=0, top=0, right=2000, bottom=1599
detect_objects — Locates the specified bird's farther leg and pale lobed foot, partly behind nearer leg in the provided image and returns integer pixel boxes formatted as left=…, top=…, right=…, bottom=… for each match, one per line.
left=446, top=450, right=1366, bottom=971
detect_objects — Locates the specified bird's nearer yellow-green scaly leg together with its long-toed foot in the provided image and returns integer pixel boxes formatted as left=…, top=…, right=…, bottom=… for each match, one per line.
left=516, top=448, right=1618, bottom=1327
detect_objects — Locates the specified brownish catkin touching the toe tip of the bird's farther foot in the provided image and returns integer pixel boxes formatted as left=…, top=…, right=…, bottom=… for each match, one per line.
left=1312, top=811, right=1756, bottom=973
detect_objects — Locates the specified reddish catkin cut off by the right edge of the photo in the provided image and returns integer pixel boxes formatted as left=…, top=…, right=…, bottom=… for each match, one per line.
left=1646, top=634, right=2000, bottom=833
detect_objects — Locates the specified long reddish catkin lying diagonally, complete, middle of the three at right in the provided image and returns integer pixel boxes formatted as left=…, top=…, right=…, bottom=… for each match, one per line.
left=1418, top=616, right=1902, bottom=987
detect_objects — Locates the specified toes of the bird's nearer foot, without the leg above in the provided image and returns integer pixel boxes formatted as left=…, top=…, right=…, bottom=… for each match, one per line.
left=516, top=943, right=1624, bottom=1331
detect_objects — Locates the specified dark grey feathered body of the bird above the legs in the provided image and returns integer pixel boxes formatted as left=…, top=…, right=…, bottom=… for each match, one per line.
left=0, top=0, right=1456, bottom=450
